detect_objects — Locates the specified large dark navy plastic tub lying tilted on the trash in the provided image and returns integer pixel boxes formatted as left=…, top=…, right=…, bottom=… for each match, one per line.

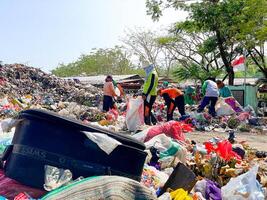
left=3, top=110, right=147, bottom=188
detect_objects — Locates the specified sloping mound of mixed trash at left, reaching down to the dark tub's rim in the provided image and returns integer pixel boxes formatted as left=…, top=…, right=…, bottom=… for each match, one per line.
left=0, top=64, right=109, bottom=122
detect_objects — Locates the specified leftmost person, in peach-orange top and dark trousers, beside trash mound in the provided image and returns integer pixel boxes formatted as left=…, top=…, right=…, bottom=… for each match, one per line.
left=103, top=75, right=117, bottom=112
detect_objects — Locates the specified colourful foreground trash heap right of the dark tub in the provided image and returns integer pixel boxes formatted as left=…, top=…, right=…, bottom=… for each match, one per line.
left=133, top=121, right=267, bottom=200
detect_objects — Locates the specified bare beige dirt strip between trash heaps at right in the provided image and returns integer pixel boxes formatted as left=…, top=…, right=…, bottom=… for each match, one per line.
left=186, top=132, right=267, bottom=151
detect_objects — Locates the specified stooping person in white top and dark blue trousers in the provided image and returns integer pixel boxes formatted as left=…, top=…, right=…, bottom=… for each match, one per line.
left=197, top=78, right=219, bottom=117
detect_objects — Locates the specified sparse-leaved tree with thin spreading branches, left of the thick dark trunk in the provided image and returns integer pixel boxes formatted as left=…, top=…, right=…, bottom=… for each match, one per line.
left=158, top=28, right=225, bottom=81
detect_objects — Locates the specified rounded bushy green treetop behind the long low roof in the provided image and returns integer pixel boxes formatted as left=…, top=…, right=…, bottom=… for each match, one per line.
left=52, top=46, right=134, bottom=77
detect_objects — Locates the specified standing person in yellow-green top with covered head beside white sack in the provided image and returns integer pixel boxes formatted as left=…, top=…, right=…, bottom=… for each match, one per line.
left=142, top=65, right=158, bottom=125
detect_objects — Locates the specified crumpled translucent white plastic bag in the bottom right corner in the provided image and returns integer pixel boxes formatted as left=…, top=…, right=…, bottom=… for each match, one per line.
left=222, top=166, right=264, bottom=200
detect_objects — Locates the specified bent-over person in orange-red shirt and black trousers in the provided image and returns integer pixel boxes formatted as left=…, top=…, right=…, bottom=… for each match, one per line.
left=158, top=88, right=185, bottom=121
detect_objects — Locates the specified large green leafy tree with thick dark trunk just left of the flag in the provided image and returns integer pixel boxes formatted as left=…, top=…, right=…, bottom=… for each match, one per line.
left=147, top=0, right=267, bottom=85
